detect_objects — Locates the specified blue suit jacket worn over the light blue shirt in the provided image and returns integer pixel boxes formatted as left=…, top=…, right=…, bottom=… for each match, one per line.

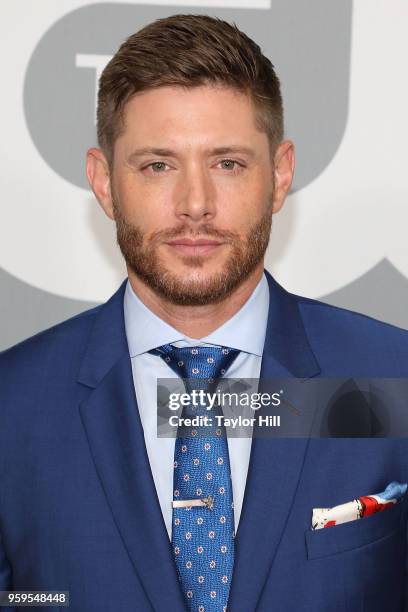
left=0, top=274, right=408, bottom=612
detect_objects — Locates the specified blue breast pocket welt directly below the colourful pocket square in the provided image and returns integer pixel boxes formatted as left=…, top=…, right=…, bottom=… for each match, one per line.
left=305, top=499, right=407, bottom=559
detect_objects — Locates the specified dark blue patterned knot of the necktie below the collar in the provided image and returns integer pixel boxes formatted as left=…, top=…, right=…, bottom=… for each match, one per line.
left=149, top=344, right=239, bottom=381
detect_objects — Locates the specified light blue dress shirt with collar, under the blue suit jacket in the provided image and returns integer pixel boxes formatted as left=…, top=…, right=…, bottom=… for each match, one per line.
left=124, top=274, right=269, bottom=540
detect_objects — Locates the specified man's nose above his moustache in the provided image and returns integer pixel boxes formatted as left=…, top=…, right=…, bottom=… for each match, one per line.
left=176, top=163, right=215, bottom=223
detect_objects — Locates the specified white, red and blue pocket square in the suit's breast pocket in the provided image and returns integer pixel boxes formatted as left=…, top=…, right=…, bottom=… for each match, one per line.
left=312, top=482, right=408, bottom=529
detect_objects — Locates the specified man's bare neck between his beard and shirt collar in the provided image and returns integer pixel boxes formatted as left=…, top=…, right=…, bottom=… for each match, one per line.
left=128, top=261, right=264, bottom=339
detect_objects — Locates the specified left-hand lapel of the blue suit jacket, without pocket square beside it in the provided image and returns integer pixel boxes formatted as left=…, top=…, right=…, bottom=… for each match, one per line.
left=79, top=282, right=186, bottom=610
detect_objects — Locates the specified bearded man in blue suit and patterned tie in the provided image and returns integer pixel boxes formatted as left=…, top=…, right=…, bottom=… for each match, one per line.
left=0, top=15, right=408, bottom=612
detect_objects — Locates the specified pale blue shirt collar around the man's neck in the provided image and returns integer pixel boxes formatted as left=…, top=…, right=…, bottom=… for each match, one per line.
left=123, top=274, right=269, bottom=357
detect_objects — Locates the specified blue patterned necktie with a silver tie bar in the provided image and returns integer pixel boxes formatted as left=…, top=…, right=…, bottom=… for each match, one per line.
left=150, top=344, right=239, bottom=612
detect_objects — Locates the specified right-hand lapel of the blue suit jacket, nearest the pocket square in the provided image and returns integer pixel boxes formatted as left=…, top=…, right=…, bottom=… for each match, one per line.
left=228, top=272, right=320, bottom=612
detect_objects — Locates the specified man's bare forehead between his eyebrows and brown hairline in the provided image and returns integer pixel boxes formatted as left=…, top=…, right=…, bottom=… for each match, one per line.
left=118, top=85, right=266, bottom=151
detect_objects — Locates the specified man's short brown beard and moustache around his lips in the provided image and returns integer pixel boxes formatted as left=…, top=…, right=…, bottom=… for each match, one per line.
left=113, top=201, right=272, bottom=306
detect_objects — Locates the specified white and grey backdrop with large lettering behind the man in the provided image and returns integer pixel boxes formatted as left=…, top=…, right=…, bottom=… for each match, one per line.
left=0, top=0, right=408, bottom=349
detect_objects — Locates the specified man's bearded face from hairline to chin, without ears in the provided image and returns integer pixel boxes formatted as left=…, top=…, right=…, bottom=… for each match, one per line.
left=96, top=86, right=286, bottom=305
